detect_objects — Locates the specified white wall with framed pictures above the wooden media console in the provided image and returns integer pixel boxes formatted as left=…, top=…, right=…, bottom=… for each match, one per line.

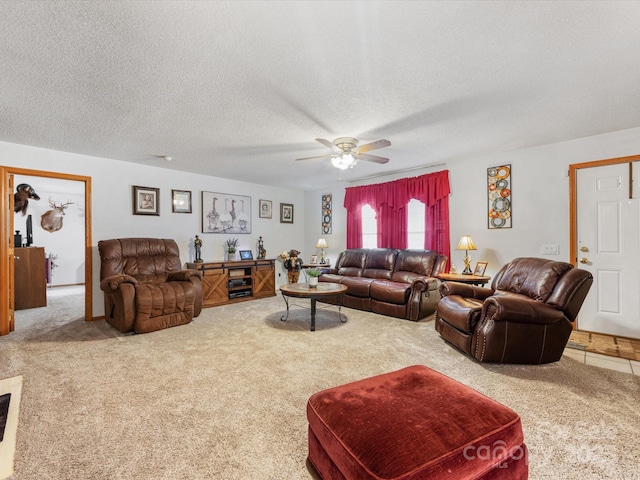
left=0, top=142, right=305, bottom=317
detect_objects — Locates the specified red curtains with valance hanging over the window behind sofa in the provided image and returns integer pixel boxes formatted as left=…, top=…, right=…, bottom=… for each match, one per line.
left=344, top=170, right=451, bottom=257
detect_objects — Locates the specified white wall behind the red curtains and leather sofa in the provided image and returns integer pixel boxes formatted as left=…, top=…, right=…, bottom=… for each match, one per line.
left=305, top=128, right=640, bottom=276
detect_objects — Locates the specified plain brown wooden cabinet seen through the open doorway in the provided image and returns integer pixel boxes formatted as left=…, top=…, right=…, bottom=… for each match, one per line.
left=13, top=247, right=47, bottom=310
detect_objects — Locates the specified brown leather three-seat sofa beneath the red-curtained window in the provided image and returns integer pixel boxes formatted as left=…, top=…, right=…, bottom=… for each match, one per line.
left=319, top=248, right=447, bottom=321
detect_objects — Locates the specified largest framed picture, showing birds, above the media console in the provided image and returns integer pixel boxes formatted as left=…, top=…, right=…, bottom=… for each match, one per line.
left=202, top=192, right=251, bottom=234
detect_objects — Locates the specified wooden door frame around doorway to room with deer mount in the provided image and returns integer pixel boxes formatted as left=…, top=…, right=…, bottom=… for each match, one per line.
left=0, top=166, right=93, bottom=335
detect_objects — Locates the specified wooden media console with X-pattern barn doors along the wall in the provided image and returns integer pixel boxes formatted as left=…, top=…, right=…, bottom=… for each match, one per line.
left=187, top=259, right=276, bottom=307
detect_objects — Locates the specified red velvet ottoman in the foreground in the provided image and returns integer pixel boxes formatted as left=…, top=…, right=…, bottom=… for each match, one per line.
left=307, top=365, right=529, bottom=480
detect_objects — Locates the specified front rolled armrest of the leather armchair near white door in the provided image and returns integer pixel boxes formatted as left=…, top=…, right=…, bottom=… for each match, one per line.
left=482, top=296, right=569, bottom=325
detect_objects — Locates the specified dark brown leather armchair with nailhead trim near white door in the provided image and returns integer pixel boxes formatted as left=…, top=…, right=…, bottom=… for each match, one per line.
left=435, top=258, right=593, bottom=364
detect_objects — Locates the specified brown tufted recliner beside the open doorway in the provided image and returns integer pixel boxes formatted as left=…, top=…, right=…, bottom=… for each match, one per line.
left=98, top=238, right=202, bottom=333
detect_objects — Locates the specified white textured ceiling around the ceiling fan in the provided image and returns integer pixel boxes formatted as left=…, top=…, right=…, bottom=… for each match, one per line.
left=0, top=0, right=640, bottom=189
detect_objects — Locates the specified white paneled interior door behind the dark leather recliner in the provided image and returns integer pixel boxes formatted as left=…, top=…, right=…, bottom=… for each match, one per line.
left=577, top=162, right=640, bottom=338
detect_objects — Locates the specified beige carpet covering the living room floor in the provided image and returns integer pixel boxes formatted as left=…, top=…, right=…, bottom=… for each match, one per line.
left=0, top=297, right=640, bottom=480
